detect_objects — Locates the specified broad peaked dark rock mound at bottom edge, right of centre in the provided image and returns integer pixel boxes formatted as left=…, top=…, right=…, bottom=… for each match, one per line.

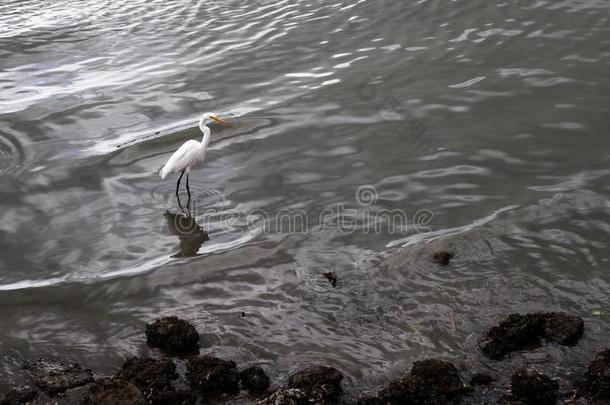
left=378, top=359, right=471, bottom=405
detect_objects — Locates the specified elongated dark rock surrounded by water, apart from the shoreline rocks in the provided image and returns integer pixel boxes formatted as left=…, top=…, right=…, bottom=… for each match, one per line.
left=479, top=312, right=584, bottom=360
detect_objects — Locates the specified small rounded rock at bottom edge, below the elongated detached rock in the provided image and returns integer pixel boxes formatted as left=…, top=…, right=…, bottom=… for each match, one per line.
left=510, top=368, right=559, bottom=405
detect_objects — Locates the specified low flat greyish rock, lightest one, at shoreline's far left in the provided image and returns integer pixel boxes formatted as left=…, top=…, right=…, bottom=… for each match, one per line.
left=23, top=359, right=93, bottom=394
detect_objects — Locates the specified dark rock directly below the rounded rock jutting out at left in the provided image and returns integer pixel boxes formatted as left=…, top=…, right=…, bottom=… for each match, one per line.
left=116, top=357, right=178, bottom=404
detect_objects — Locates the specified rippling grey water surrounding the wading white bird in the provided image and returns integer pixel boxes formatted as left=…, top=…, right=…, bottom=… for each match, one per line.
left=0, top=0, right=610, bottom=397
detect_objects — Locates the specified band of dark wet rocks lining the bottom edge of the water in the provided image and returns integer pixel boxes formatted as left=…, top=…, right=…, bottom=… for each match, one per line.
left=0, top=312, right=610, bottom=405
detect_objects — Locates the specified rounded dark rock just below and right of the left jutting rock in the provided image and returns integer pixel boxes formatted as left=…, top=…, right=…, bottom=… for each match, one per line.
left=186, top=355, right=239, bottom=393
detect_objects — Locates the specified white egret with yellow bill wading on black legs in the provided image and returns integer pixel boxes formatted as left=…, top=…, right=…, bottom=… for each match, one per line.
left=159, top=112, right=227, bottom=207
